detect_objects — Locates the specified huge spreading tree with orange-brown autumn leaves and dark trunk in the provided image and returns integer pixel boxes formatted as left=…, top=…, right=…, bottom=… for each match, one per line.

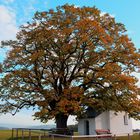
left=0, top=5, right=140, bottom=128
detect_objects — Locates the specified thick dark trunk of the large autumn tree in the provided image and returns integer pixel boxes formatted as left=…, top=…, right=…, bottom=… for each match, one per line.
left=55, top=113, right=68, bottom=128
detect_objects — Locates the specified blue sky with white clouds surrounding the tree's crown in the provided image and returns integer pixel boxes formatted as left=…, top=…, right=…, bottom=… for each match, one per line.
left=0, top=0, right=140, bottom=128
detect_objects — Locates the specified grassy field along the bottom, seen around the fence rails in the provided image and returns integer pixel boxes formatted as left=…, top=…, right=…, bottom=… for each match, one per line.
left=0, top=130, right=140, bottom=140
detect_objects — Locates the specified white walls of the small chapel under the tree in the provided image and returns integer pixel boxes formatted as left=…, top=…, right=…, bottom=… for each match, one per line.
left=78, top=111, right=132, bottom=135
